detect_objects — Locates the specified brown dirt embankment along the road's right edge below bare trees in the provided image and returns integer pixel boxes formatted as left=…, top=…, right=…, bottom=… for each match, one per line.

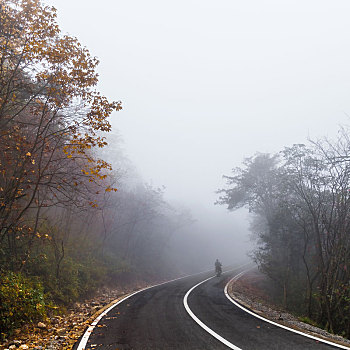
left=228, top=269, right=350, bottom=349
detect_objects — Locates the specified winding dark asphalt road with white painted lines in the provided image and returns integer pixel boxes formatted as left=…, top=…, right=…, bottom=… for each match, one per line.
left=78, top=268, right=346, bottom=350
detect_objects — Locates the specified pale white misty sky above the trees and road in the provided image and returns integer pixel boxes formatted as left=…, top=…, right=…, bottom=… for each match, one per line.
left=45, top=0, right=350, bottom=262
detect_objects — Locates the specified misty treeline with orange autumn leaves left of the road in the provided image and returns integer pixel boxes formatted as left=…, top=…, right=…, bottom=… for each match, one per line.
left=0, top=0, right=188, bottom=337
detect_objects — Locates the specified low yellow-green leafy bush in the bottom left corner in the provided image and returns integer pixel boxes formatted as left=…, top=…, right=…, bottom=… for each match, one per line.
left=0, top=272, right=46, bottom=338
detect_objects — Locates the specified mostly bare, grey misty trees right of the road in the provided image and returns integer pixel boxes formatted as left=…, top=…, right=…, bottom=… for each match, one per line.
left=219, top=128, right=350, bottom=337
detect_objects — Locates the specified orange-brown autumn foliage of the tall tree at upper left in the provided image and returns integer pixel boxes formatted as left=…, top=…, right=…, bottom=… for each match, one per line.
left=0, top=0, right=121, bottom=268
